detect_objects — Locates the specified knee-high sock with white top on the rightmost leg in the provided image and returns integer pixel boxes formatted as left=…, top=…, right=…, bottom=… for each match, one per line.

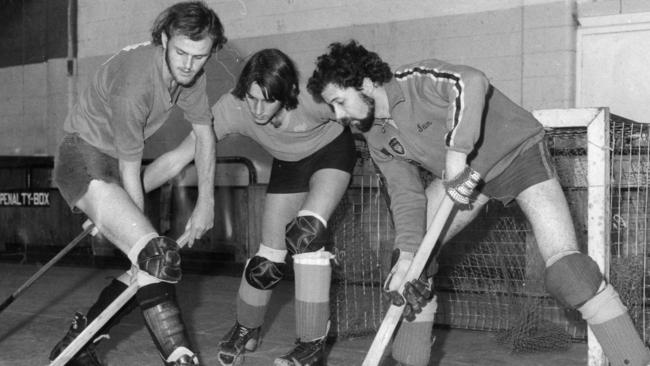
left=578, top=285, right=650, bottom=366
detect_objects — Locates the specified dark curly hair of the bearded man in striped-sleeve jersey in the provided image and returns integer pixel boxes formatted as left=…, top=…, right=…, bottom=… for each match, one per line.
left=307, top=40, right=393, bottom=102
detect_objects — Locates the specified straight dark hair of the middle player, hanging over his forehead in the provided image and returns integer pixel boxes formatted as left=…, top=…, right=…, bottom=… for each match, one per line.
left=231, top=48, right=300, bottom=110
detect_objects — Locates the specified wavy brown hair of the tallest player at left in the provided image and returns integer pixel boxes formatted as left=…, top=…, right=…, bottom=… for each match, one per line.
left=151, top=1, right=228, bottom=52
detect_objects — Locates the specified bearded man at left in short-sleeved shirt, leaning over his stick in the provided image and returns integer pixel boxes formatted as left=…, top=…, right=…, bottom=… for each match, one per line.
left=50, top=2, right=226, bottom=365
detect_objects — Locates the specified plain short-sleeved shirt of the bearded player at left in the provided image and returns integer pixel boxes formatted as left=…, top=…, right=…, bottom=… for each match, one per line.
left=64, top=43, right=212, bottom=161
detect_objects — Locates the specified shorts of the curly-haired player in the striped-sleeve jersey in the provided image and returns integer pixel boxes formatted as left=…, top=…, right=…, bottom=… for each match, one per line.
left=481, top=140, right=557, bottom=205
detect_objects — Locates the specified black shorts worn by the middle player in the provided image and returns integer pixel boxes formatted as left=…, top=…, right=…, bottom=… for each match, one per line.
left=266, top=128, right=357, bottom=193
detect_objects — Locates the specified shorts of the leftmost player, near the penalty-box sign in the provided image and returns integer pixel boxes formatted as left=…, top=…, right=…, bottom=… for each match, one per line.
left=52, top=134, right=122, bottom=211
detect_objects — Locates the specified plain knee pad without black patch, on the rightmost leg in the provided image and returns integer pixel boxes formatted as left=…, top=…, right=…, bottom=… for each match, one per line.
left=544, top=252, right=603, bottom=309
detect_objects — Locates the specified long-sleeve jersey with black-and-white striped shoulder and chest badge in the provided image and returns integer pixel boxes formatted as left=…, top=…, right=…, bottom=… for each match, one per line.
left=365, top=60, right=544, bottom=251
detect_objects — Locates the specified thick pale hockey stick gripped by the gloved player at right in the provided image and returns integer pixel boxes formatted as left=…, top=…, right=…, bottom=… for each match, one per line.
left=361, top=195, right=454, bottom=366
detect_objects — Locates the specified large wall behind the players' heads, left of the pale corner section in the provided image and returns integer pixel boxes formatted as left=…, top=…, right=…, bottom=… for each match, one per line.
left=0, top=0, right=576, bottom=161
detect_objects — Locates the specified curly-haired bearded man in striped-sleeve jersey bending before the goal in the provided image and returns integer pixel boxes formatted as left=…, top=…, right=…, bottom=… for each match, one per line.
left=308, top=41, right=650, bottom=366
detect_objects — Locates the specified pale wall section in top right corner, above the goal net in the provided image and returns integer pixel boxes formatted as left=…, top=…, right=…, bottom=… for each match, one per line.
left=576, top=0, right=650, bottom=122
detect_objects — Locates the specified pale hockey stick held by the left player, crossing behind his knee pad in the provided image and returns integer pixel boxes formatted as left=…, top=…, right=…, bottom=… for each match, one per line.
left=49, top=233, right=189, bottom=366
